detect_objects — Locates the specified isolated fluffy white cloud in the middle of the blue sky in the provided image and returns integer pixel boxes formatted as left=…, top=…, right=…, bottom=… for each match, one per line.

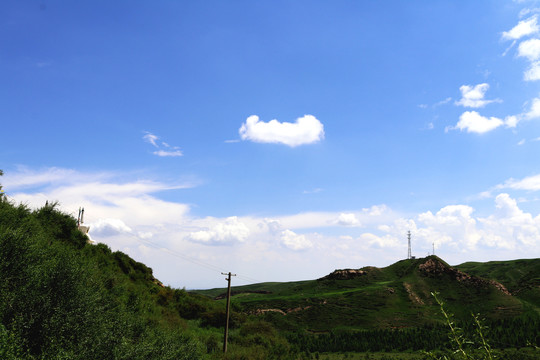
left=239, top=115, right=324, bottom=147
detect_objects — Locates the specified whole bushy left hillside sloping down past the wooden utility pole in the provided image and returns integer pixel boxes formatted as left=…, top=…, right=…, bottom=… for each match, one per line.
left=0, top=196, right=297, bottom=360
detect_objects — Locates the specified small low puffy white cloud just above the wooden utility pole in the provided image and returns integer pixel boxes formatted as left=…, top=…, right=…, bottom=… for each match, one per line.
left=186, top=216, right=250, bottom=244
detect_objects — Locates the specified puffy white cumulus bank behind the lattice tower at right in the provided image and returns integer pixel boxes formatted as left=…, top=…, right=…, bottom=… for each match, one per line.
left=358, top=193, right=540, bottom=257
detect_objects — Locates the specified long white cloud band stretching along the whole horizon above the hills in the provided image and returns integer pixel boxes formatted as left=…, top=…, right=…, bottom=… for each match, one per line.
left=3, top=169, right=540, bottom=288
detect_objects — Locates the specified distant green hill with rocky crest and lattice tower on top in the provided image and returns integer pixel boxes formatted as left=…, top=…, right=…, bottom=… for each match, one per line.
left=197, top=256, right=540, bottom=332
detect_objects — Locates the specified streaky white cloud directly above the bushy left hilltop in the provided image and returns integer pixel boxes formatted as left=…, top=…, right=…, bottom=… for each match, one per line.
left=4, top=168, right=193, bottom=226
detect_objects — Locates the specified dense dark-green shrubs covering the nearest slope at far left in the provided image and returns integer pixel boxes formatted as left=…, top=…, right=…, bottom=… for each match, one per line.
left=0, top=201, right=201, bottom=359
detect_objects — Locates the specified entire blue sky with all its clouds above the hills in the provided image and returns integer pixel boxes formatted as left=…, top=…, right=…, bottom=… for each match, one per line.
left=0, top=0, right=540, bottom=288
